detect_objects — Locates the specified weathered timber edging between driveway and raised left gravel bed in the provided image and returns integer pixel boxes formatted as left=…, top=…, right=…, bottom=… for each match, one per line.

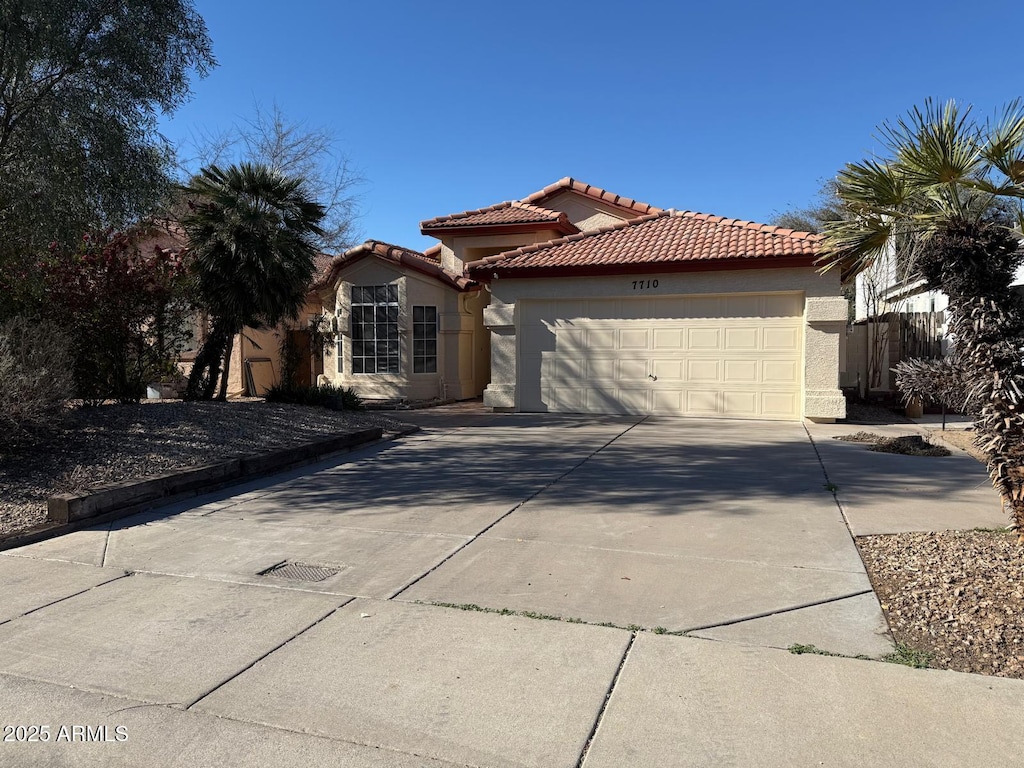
left=0, top=426, right=420, bottom=551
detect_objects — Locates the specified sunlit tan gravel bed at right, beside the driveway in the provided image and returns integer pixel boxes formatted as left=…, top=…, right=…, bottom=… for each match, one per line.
left=857, top=530, right=1024, bottom=678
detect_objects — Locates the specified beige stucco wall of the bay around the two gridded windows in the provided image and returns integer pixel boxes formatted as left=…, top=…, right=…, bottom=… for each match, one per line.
left=324, top=258, right=486, bottom=400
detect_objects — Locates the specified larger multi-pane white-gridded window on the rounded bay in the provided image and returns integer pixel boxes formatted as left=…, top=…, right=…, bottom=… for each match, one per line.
left=352, top=284, right=400, bottom=374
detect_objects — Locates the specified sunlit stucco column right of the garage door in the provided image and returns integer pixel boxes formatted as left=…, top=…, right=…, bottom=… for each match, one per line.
left=804, top=296, right=849, bottom=422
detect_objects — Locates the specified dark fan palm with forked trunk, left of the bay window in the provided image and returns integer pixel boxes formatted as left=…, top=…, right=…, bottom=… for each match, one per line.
left=181, top=163, right=324, bottom=399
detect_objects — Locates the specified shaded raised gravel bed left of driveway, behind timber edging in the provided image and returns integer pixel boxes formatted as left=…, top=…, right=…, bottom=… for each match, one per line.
left=0, top=400, right=409, bottom=537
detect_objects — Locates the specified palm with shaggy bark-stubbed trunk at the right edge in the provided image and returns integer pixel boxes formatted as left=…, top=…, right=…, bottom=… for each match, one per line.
left=821, top=101, right=1024, bottom=542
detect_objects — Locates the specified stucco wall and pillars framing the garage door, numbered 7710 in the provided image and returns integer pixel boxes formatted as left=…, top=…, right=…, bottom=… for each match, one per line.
left=483, top=268, right=847, bottom=421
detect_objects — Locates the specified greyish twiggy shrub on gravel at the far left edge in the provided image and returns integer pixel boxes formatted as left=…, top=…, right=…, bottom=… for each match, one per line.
left=0, top=317, right=74, bottom=451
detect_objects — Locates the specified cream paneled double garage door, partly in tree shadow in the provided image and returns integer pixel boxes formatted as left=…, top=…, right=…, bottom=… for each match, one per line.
left=518, top=294, right=804, bottom=420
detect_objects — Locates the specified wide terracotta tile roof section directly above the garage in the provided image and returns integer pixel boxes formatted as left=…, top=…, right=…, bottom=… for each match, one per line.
left=466, top=210, right=821, bottom=280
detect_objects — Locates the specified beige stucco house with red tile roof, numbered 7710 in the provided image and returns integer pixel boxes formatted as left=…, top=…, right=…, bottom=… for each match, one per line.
left=314, top=178, right=847, bottom=421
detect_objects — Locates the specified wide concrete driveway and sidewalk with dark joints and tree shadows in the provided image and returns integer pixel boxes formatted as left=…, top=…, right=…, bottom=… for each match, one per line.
left=0, top=408, right=1024, bottom=768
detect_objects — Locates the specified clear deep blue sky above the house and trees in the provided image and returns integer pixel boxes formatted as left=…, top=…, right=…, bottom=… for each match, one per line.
left=161, top=0, right=1024, bottom=249
